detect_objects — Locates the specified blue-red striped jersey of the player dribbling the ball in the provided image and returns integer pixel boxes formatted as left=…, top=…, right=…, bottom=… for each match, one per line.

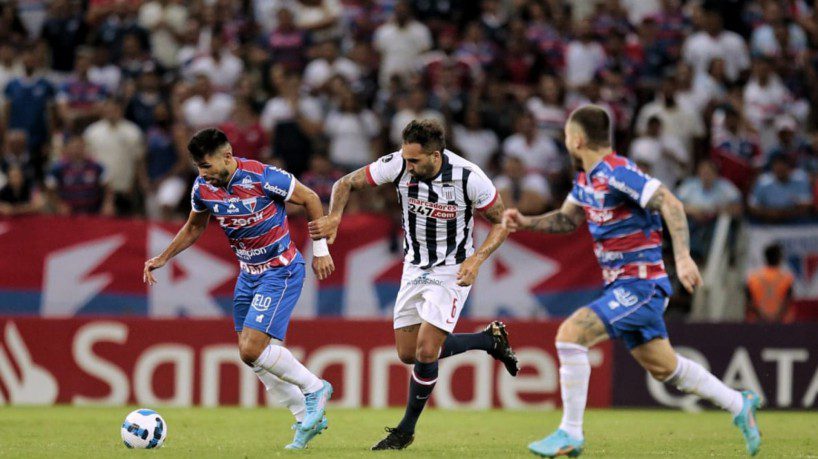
left=191, top=158, right=298, bottom=274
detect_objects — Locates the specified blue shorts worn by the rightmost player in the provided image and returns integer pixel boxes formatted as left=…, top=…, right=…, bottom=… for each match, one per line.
left=588, top=280, right=668, bottom=349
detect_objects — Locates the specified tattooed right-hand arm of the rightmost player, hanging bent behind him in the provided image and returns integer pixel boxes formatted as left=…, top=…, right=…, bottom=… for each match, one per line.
left=646, top=185, right=702, bottom=293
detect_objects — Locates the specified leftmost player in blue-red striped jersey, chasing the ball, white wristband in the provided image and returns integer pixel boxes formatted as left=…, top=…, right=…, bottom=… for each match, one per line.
left=143, top=129, right=335, bottom=449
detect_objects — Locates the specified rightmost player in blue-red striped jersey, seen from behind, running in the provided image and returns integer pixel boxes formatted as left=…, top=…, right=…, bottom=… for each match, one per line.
left=503, top=105, right=761, bottom=457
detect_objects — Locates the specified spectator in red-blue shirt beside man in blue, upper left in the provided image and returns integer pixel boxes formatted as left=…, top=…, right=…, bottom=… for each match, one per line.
left=56, top=48, right=108, bottom=130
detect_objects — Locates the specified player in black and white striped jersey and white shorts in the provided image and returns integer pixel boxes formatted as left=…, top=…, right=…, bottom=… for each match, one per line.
left=310, top=120, right=518, bottom=450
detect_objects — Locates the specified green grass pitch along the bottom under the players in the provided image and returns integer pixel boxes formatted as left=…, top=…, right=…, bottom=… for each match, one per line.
left=0, top=406, right=818, bottom=459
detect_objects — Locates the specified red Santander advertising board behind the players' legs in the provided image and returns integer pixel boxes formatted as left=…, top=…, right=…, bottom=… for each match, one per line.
left=0, top=317, right=613, bottom=409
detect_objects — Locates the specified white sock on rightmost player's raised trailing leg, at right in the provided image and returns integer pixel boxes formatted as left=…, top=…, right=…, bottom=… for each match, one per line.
left=665, top=354, right=744, bottom=416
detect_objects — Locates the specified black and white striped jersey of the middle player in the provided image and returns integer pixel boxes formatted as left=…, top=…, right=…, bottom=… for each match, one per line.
left=366, top=150, right=497, bottom=268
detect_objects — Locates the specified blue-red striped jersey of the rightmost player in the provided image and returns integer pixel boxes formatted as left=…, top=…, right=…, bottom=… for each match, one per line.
left=568, top=154, right=671, bottom=295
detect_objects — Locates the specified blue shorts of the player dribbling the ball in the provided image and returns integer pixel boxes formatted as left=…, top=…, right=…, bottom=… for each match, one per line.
left=233, top=255, right=304, bottom=341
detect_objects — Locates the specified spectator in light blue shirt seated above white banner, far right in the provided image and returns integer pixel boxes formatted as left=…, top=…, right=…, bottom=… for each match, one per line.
left=749, top=156, right=812, bottom=223
